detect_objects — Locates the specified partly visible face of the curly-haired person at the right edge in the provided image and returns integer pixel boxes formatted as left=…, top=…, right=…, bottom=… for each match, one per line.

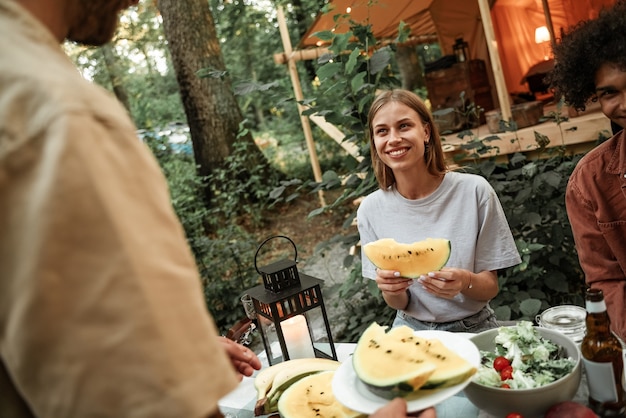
left=595, top=64, right=626, bottom=128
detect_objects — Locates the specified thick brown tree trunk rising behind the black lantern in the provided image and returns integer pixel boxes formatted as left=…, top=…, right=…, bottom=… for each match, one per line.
left=159, top=0, right=268, bottom=196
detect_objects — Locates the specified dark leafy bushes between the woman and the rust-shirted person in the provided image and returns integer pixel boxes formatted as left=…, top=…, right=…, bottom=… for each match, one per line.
left=458, top=153, right=584, bottom=320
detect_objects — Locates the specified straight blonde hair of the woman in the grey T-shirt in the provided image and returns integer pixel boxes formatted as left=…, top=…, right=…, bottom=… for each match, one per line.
left=367, top=89, right=448, bottom=190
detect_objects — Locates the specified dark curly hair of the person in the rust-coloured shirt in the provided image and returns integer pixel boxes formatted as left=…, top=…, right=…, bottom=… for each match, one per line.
left=549, top=0, right=626, bottom=111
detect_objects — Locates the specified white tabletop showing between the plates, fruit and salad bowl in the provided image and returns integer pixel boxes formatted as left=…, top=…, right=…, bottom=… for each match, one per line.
left=219, top=343, right=588, bottom=418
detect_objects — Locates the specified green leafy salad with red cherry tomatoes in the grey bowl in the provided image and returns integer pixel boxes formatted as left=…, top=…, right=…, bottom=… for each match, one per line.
left=474, top=321, right=576, bottom=389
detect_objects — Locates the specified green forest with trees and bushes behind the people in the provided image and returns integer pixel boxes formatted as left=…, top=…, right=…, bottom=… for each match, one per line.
left=65, top=0, right=605, bottom=341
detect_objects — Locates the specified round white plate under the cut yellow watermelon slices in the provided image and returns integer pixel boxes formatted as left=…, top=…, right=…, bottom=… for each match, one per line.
left=332, top=331, right=480, bottom=414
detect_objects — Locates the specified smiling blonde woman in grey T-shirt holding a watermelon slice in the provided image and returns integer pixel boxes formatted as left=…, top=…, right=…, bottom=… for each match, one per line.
left=357, top=90, right=521, bottom=332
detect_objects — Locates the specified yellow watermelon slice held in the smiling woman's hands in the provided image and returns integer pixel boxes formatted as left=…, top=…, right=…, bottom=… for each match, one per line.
left=363, top=238, right=452, bottom=278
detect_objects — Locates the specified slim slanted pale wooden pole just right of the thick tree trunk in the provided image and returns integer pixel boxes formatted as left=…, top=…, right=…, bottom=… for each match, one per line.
left=276, top=5, right=326, bottom=206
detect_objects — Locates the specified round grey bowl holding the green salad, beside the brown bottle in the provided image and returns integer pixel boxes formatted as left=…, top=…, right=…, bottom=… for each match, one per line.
left=465, top=325, right=582, bottom=418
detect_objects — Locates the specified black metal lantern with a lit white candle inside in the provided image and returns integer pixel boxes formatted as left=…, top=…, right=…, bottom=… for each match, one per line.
left=246, top=235, right=337, bottom=366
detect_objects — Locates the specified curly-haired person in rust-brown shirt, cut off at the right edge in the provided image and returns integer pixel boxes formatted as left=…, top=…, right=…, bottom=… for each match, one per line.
left=551, top=0, right=626, bottom=344
